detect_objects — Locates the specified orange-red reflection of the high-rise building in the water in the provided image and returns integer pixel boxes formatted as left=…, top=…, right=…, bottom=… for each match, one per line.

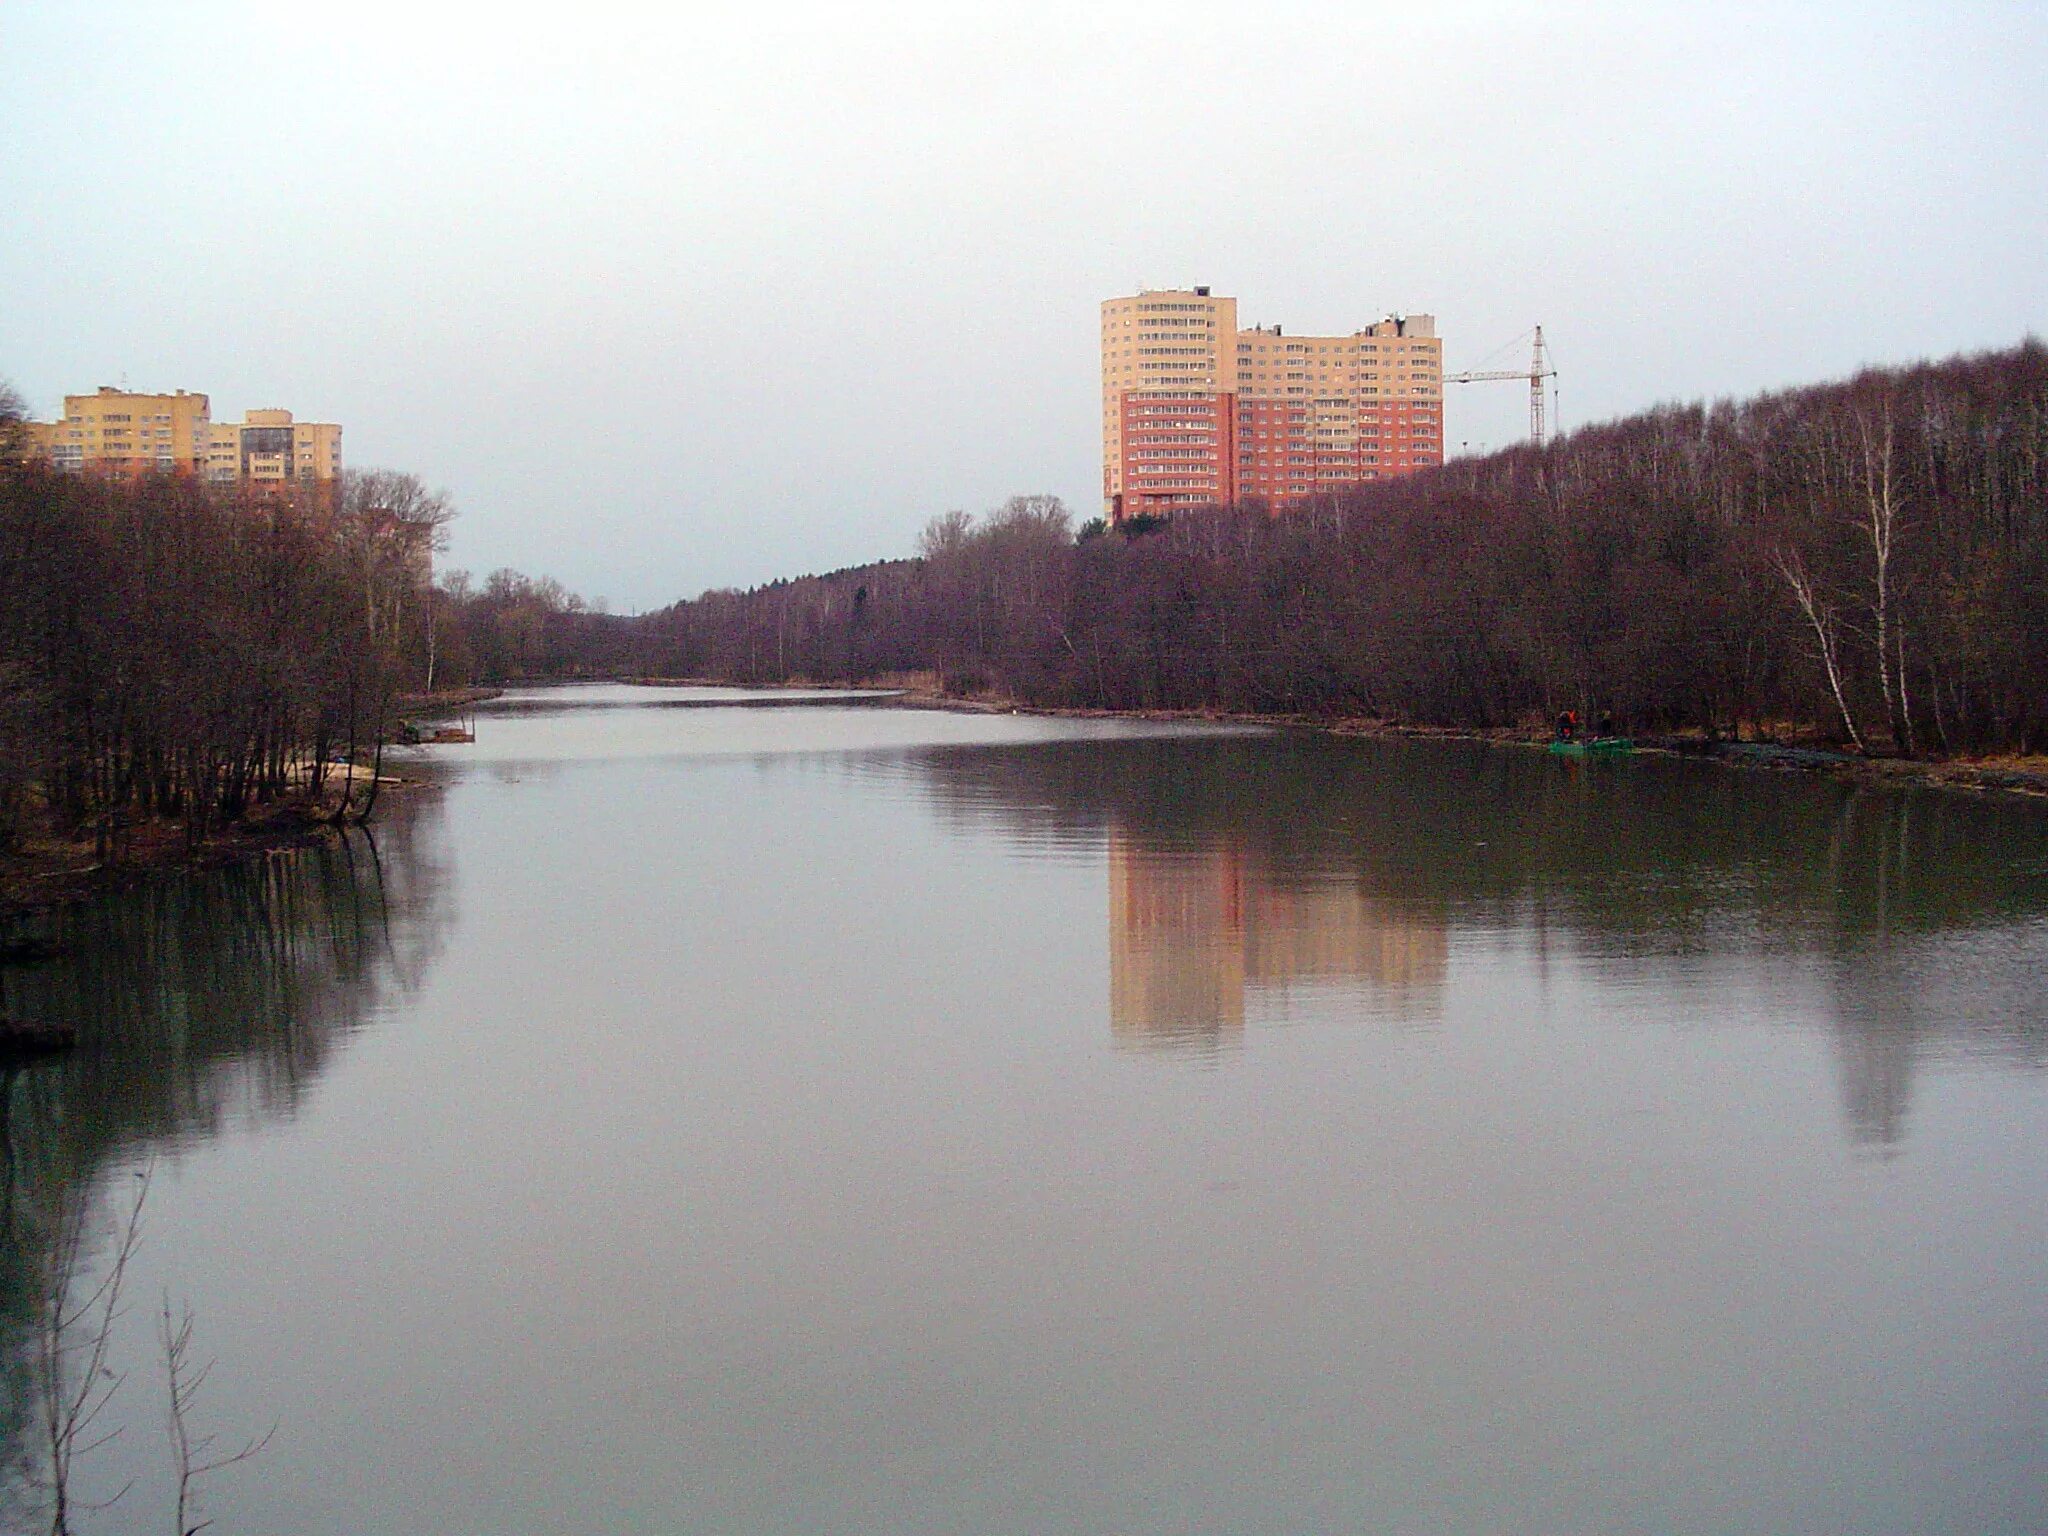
left=1110, top=827, right=1448, bottom=1044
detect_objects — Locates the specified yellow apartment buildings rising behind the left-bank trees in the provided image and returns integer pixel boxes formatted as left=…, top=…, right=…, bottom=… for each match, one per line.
left=27, top=385, right=342, bottom=489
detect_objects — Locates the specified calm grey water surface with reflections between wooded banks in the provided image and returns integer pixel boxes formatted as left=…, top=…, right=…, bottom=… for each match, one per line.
left=0, top=688, right=2048, bottom=1534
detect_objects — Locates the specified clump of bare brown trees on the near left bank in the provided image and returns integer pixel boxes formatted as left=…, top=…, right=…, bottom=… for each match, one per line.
left=0, top=387, right=449, bottom=852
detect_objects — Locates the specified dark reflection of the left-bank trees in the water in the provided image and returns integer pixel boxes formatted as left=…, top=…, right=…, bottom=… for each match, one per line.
left=0, top=801, right=451, bottom=1515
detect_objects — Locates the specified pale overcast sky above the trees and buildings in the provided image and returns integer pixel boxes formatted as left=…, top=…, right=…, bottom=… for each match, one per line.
left=0, top=0, right=2048, bottom=608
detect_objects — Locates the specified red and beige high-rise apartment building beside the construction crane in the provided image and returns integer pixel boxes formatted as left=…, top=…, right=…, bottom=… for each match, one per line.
left=1102, top=289, right=1444, bottom=522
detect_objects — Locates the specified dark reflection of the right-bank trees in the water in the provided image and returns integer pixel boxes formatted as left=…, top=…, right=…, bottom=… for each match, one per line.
left=897, top=733, right=2048, bottom=1143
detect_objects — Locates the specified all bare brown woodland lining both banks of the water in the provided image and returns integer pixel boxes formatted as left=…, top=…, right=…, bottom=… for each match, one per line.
left=0, top=340, right=2048, bottom=925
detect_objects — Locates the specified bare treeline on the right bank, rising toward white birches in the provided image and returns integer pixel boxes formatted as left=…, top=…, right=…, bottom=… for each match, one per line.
left=602, top=342, right=2048, bottom=754
